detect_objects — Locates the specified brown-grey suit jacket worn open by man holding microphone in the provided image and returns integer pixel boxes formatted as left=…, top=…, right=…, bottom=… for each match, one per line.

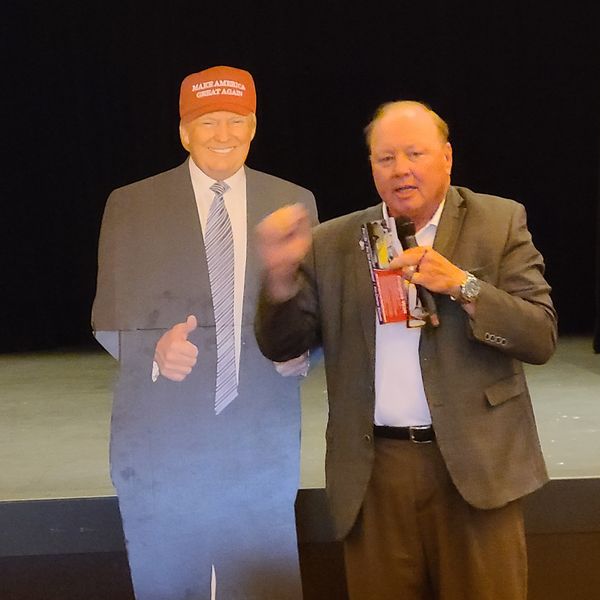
left=256, top=187, right=556, bottom=537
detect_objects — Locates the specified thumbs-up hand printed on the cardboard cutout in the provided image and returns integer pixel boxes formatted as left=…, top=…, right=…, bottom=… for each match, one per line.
left=154, top=315, right=198, bottom=381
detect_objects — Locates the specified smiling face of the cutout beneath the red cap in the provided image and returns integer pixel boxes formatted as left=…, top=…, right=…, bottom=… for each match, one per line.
left=179, top=110, right=256, bottom=181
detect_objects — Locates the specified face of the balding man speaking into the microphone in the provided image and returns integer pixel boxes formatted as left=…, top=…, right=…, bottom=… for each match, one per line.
left=370, top=102, right=452, bottom=230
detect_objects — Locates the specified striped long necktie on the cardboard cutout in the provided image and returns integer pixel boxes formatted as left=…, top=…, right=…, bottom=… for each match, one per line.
left=204, top=181, right=238, bottom=414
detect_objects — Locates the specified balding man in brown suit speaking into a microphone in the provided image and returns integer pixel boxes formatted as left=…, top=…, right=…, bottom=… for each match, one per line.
left=256, top=101, right=556, bottom=600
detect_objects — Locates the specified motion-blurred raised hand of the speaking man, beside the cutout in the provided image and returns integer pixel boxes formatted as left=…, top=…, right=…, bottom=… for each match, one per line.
left=256, top=204, right=312, bottom=302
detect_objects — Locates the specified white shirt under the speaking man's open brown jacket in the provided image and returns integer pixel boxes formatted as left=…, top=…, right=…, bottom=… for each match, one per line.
left=374, top=201, right=444, bottom=427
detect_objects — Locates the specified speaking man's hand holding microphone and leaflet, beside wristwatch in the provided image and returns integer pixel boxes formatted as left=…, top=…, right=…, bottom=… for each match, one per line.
left=389, top=246, right=466, bottom=296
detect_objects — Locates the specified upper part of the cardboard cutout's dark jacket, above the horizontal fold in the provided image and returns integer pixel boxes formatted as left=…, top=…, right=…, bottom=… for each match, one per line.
left=92, top=161, right=317, bottom=331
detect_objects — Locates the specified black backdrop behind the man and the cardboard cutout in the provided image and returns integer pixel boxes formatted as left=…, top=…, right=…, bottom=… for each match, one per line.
left=0, top=0, right=600, bottom=352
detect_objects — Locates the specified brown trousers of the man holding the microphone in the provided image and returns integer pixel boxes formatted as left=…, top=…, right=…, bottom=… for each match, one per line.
left=344, top=438, right=527, bottom=600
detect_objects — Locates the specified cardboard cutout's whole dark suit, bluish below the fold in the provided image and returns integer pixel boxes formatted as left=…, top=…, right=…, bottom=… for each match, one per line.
left=93, top=163, right=316, bottom=600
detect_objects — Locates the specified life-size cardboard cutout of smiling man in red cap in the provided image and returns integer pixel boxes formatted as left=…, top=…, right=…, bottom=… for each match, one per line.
left=93, top=66, right=316, bottom=600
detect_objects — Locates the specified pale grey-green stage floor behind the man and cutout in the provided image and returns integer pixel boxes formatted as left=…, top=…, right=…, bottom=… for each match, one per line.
left=0, top=337, right=600, bottom=501
